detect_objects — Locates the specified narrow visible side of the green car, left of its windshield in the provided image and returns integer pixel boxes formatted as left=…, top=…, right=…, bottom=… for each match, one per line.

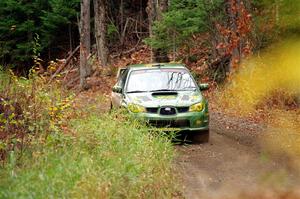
left=111, top=68, right=128, bottom=108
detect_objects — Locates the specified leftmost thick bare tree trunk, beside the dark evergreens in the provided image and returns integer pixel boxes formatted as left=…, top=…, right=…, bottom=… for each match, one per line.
left=79, top=0, right=92, bottom=89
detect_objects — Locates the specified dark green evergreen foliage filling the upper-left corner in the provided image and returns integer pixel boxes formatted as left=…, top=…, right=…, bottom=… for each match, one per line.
left=0, top=0, right=79, bottom=67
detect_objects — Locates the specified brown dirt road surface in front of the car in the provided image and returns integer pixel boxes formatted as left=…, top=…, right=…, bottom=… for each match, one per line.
left=176, top=114, right=300, bottom=199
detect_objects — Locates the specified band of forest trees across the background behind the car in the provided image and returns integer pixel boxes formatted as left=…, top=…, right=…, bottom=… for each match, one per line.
left=0, top=0, right=299, bottom=80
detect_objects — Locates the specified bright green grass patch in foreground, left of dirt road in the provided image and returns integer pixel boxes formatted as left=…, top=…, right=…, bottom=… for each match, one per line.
left=0, top=109, right=176, bottom=198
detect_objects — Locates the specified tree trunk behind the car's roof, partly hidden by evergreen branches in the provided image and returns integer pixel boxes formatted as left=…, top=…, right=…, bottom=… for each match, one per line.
left=146, top=0, right=170, bottom=63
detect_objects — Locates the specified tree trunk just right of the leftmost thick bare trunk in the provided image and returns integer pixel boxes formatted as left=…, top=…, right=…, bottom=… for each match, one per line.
left=94, top=0, right=109, bottom=66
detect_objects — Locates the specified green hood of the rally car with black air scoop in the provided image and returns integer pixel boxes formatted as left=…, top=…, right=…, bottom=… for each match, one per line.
left=125, top=91, right=203, bottom=108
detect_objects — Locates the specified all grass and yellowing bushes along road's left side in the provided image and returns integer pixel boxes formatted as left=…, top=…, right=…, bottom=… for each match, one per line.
left=0, top=71, right=176, bottom=198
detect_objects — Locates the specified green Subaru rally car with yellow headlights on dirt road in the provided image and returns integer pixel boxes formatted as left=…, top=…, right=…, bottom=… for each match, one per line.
left=111, top=63, right=209, bottom=142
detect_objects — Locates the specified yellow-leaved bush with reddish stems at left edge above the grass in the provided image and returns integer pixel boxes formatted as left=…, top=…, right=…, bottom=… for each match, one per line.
left=0, top=66, right=73, bottom=161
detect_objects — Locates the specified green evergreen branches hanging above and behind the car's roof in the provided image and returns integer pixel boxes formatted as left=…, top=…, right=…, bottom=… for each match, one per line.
left=146, top=0, right=222, bottom=50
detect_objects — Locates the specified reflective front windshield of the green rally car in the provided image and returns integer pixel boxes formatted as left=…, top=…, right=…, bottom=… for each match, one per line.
left=126, top=68, right=196, bottom=93
